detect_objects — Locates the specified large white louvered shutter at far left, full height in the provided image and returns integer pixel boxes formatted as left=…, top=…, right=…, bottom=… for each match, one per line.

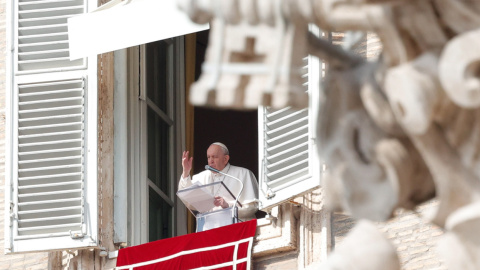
left=5, top=0, right=98, bottom=252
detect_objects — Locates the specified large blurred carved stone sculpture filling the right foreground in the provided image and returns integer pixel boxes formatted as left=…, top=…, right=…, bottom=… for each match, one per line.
left=178, top=0, right=480, bottom=269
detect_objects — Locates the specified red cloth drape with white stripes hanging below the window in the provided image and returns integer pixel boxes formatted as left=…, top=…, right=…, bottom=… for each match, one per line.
left=117, top=220, right=257, bottom=270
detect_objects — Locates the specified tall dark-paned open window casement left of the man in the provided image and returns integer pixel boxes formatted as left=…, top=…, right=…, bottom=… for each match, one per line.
left=114, top=37, right=187, bottom=246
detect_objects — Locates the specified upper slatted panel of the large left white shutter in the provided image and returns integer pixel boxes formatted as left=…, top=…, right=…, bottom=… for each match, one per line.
left=14, top=0, right=87, bottom=74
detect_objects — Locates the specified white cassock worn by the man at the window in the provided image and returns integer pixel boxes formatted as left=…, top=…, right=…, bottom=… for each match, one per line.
left=178, top=163, right=258, bottom=224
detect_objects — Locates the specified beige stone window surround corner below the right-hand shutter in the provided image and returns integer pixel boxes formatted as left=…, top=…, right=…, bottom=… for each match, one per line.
left=253, top=189, right=331, bottom=270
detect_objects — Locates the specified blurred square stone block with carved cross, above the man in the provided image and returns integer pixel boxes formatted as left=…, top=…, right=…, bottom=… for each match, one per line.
left=178, top=0, right=308, bottom=109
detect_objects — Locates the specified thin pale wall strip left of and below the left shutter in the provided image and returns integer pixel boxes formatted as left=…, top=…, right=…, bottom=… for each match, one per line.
left=0, top=0, right=48, bottom=270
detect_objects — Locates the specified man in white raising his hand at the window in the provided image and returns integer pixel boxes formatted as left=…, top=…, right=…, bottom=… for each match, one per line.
left=178, top=142, right=258, bottom=229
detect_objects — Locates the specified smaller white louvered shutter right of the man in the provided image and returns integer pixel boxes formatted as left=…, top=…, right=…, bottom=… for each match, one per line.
left=258, top=42, right=322, bottom=210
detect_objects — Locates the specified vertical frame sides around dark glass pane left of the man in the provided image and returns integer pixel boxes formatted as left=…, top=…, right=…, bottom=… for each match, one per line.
left=120, top=36, right=186, bottom=246
